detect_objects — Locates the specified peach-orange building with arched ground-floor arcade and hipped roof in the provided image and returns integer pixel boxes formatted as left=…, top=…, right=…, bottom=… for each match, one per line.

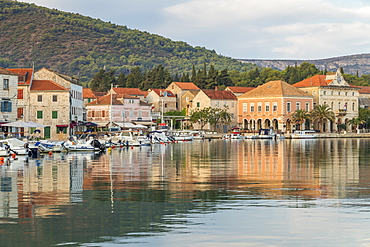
left=238, top=81, right=313, bottom=131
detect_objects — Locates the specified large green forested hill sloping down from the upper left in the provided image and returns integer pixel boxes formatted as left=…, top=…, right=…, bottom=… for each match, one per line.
left=0, top=0, right=255, bottom=82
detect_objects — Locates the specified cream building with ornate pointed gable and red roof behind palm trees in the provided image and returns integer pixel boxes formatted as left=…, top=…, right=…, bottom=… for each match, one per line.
left=293, top=69, right=360, bottom=132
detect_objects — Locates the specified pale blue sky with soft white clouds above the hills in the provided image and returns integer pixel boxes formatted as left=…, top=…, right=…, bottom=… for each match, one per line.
left=20, top=0, right=370, bottom=59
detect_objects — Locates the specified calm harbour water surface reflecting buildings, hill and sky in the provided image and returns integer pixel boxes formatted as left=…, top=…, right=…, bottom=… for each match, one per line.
left=0, top=139, right=370, bottom=247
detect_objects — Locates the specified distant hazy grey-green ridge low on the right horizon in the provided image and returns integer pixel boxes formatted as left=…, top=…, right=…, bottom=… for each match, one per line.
left=239, top=54, right=370, bottom=75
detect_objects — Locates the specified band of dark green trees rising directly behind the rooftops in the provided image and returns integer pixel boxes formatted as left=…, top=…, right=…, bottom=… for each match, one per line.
left=89, top=62, right=370, bottom=91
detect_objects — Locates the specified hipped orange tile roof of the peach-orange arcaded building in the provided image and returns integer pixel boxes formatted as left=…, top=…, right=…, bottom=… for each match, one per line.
left=238, top=81, right=312, bottom=98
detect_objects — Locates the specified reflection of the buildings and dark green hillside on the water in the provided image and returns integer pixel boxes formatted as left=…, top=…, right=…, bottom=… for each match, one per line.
left=0, top=139, right=370, bottom=246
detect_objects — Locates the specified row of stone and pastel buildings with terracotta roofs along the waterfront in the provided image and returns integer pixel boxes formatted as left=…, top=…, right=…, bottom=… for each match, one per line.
left=0, top=68, right=370, bottom=139
